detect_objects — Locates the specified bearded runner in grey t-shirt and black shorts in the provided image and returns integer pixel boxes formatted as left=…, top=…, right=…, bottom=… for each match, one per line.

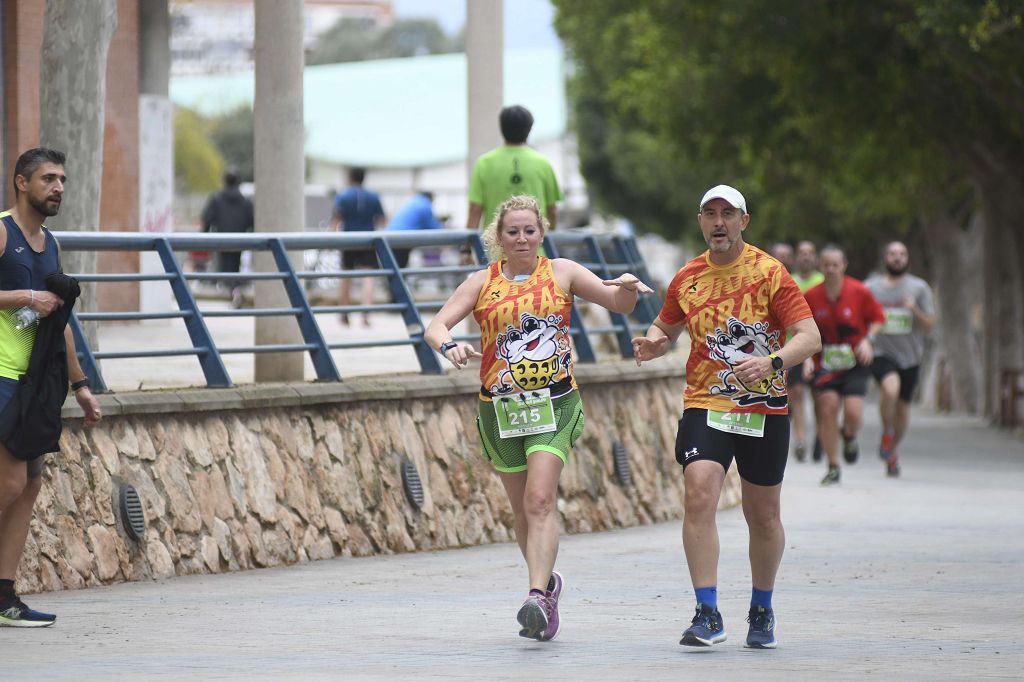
left=864, top=242, right=936, bottom=476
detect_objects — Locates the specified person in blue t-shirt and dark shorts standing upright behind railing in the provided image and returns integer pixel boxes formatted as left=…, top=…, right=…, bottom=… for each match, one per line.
left=331, top=168, right=384, bottom=327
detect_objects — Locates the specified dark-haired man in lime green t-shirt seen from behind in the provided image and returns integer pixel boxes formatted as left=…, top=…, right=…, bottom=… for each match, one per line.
left=467, top=104, right=563, bottom=229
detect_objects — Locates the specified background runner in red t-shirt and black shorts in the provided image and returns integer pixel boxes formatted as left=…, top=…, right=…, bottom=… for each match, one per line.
left=804, top=246, right=886, bottom=485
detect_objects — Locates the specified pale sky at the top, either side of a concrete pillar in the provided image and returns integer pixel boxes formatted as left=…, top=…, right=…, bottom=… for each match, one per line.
left=393, top=0, right=560, bottom=49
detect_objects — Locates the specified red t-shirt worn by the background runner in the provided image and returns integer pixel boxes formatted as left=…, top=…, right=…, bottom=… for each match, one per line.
left=804, top=275, right=886, bottom=369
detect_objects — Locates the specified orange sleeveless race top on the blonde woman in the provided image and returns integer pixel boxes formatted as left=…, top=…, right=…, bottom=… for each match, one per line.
left=473, top=256, right=575, bottom=399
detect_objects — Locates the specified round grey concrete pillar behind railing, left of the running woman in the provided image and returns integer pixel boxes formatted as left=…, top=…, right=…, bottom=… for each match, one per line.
left=253, top=0, right=306, bottom=382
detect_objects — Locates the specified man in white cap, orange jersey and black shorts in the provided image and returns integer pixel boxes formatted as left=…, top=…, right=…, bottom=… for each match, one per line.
left=633, top=185, right=819, bottom=648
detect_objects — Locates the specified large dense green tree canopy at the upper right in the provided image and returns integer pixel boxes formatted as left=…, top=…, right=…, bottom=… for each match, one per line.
left=554, top=0, right=1024, bottom=266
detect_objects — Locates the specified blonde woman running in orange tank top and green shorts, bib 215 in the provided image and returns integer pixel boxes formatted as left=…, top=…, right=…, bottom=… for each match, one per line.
left=426, top=196, right=651, bottom=641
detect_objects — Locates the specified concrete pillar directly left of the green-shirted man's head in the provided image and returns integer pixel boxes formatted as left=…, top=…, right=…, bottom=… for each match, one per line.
left=466, top=0, right=505, bottom=196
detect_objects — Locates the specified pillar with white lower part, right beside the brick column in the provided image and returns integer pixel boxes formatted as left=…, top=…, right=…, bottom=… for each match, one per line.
left=138, top=0, right=176, bottom=313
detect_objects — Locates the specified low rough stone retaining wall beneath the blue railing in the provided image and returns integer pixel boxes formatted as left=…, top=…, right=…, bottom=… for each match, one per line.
left=17, top=363, right=738, bottom=593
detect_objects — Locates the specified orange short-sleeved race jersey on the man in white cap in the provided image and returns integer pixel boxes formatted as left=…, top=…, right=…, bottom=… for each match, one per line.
left=658, top=244, right=811, bottom=415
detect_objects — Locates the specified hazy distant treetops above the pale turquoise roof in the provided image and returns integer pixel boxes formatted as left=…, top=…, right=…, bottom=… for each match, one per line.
left=306, top=18, right=463, bottom=65
